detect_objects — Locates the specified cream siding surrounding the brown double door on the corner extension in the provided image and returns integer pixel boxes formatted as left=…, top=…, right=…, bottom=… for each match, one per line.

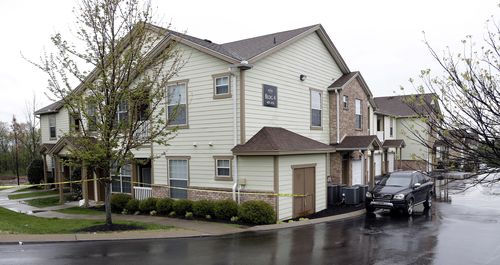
left=278, top=154, right=326, bottom=220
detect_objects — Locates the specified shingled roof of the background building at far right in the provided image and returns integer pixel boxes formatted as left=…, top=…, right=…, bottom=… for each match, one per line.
left=374, top=93, right=435, bottom=117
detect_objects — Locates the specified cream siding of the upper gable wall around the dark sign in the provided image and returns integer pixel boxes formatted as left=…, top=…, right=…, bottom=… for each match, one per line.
left=245, top=33, right=342, bottom=143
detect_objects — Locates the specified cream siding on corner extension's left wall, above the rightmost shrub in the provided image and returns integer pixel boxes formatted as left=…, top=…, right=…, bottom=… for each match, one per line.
left=238, top=156, right=274, bottom=191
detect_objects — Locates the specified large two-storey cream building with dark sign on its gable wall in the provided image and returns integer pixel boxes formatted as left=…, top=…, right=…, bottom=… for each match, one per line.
left=36, top=25, right=383, bottom=220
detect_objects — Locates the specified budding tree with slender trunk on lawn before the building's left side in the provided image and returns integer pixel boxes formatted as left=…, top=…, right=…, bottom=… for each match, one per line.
left=27, top=0, right=184, bottom=225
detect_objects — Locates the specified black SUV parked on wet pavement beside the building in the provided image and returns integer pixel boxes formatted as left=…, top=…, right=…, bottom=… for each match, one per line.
left=365, top=171, right=434, bottom=215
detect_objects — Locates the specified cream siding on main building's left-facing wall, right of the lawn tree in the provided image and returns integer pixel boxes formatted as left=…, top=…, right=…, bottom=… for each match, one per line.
left=153, top=44, right=238, bottom=188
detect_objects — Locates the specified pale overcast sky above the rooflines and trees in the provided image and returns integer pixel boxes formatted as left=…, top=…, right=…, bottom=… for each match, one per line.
left=0, top=0, right=499, bottom=121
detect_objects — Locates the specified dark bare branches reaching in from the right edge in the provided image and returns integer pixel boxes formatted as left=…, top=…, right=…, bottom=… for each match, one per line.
left=407, top=18, right=500, bottom=183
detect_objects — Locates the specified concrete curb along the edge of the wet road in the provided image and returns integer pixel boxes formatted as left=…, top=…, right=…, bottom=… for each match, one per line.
left=0, top=209, right=366, bottom=245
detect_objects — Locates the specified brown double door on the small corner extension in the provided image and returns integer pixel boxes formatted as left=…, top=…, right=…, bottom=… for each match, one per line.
left=293, top=167, right=316, bottom=218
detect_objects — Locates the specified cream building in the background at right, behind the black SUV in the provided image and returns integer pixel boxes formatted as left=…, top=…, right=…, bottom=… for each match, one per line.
left=372, top=94, right=439, bottom=171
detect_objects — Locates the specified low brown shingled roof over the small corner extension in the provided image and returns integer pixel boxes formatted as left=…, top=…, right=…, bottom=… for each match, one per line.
left=232, top=127, right=334, bottom=155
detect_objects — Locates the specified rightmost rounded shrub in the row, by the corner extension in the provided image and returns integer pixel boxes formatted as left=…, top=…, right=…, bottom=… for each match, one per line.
left=239, top=201, right=276, bottom=225
